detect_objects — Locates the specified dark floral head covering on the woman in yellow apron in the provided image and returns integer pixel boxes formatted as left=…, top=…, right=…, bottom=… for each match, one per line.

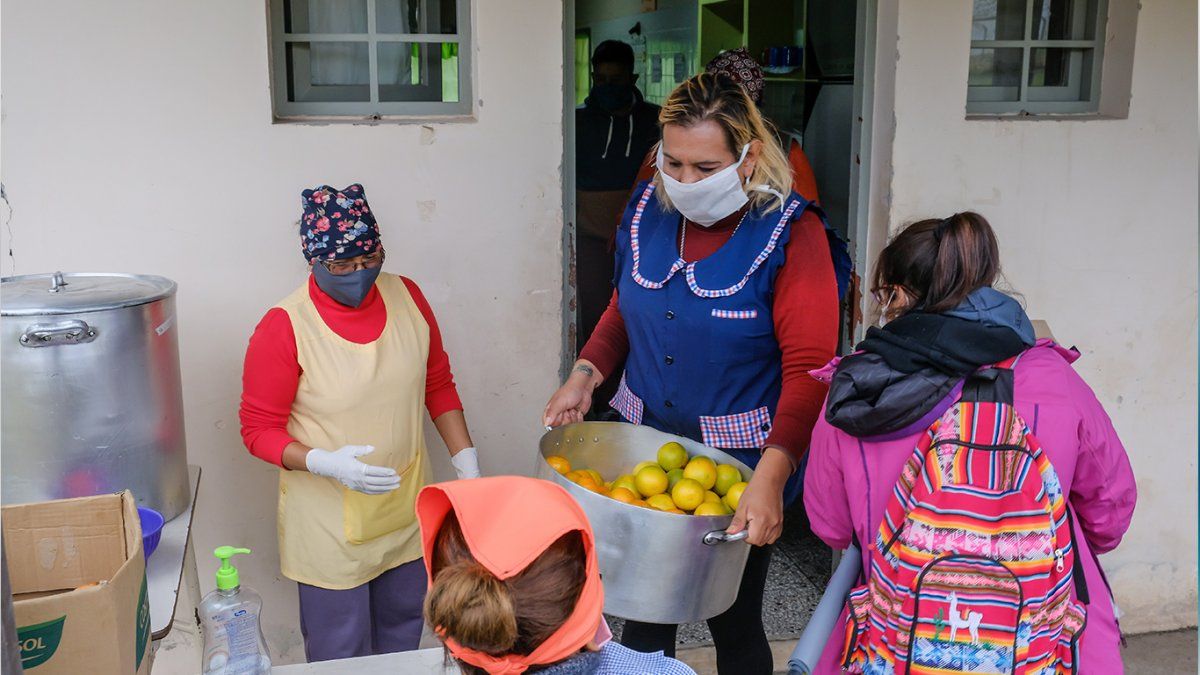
left=300, top=183, right=379, bottom=262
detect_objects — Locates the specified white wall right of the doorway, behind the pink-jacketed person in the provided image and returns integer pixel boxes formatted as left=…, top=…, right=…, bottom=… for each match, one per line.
left=872, top=0, right=1198, bottom=632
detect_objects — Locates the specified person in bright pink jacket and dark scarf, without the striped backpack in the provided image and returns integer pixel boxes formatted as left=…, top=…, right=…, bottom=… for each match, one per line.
left=804, top=213, right=1136, bottom=674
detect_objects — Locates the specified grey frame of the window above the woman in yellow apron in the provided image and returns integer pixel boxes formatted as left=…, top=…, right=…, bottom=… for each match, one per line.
left=268, top=0, right=475, bottom=123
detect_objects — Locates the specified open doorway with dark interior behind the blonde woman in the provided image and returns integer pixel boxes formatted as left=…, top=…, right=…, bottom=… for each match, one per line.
left=563, top=0, right=876, bottom=374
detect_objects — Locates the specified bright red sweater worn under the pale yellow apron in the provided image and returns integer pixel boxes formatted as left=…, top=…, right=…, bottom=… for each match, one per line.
left=238, top=270, right=462, bottom=466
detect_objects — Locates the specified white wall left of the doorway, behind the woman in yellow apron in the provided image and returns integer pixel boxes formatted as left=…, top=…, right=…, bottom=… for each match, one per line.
left=0, top=0, right=563, bottom=662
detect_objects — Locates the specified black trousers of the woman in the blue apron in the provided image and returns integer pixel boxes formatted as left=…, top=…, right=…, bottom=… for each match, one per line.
left=620, top=546, right=774, bottom=675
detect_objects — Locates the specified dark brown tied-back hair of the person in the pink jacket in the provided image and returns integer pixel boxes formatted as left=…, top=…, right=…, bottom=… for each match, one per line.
left=871, top=211, right=1000, bottom=312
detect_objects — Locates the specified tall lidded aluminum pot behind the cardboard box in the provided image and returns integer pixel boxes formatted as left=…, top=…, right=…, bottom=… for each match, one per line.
left=0, top=273, right=188, bottom=519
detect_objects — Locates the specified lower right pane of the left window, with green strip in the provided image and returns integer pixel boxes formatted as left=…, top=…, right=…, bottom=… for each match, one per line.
left=379, top=42, right=458, bottom=102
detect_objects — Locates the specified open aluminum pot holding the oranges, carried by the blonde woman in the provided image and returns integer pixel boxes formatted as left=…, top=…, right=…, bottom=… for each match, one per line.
left=535, top=422, right=752, bottom=623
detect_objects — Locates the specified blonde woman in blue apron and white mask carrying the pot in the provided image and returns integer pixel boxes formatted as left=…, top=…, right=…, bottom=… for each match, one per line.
left=545, top=73, right=844, bottom=675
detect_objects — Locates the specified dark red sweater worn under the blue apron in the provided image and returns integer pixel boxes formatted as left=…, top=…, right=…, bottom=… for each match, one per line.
left=580, top=205, right=838, bottom=461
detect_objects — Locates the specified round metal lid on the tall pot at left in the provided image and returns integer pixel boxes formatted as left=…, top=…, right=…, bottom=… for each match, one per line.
left=0, top=273, right=175, bottom=316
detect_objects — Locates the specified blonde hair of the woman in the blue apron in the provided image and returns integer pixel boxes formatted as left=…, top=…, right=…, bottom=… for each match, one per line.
left=654, top=72, right=792, bottom=210
